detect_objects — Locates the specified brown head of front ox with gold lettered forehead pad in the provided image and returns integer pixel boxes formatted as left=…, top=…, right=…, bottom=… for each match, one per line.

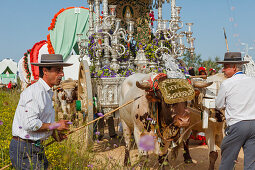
left=136, top=78, right=195, bottom=127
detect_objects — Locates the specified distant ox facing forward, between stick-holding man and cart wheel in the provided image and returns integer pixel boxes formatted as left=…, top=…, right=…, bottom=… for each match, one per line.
left=55, top=79, right=78, bottom=121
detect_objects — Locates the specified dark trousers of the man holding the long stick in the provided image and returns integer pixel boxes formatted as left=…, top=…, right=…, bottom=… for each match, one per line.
left=9, top=139, right=48, bottom=170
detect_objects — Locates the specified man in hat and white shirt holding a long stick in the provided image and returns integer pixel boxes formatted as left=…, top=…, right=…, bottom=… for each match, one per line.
left=10, top=54, right=72, bottom=169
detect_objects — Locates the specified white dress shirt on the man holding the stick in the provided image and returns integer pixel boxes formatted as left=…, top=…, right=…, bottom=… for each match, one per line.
left=12, top=78, right=55, bottom=141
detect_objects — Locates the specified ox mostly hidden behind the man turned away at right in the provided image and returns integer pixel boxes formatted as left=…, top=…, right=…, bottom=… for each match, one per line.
left=183, top=73, right=226, bottom=170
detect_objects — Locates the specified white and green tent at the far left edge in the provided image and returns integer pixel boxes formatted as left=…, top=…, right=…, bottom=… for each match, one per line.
left=0, top=59, right=18, bottom=84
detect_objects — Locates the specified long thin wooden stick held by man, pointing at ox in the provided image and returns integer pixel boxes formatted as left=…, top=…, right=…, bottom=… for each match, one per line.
left=45, top=95, right=143, bottom=147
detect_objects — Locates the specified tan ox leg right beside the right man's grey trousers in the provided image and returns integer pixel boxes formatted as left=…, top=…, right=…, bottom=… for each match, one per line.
left=205, top=125, right=218, bottom=170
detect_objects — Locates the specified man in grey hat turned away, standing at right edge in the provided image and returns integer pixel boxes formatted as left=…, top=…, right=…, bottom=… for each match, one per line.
left=216, top=52, right=255, bottom=170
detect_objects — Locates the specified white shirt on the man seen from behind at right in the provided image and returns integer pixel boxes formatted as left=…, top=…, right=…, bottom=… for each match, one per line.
left=216, top=72, right=255, bottom=126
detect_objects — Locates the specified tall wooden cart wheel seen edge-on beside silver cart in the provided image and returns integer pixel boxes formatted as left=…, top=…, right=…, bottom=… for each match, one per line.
left=78, top=60, right=94, bottom=148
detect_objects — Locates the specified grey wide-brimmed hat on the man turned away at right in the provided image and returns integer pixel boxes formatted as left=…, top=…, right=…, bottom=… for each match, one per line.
left=217, top=52, right=249, bottom=64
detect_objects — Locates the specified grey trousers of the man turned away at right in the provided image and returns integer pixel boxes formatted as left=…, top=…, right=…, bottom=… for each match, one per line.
left=219, top=120, right=255, bottom=170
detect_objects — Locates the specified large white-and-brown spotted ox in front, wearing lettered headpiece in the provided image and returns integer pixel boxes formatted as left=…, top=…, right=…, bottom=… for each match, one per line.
left=120, top=73, right=197, bottom=165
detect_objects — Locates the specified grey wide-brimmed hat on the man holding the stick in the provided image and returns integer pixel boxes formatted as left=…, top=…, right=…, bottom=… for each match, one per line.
left=31, top=54, right=73, bottom=67
